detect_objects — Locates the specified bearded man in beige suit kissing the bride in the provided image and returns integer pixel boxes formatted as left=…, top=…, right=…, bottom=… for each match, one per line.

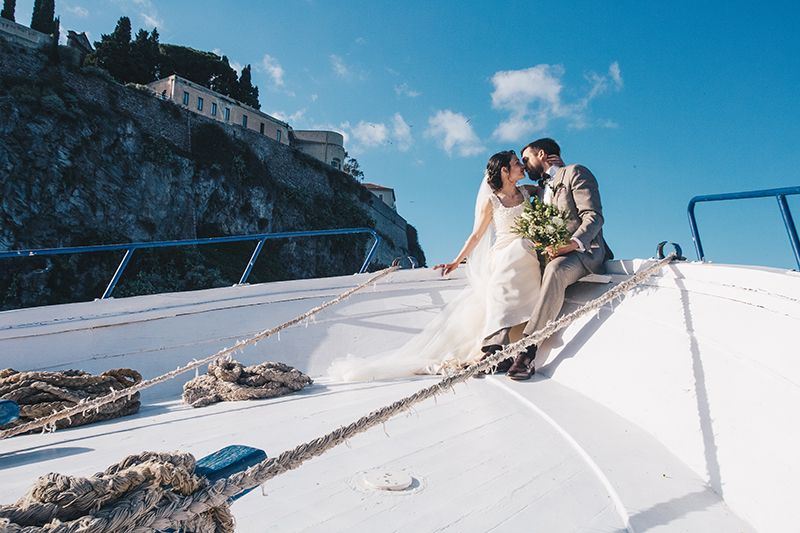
left=508, top=138, right=614, bottom=380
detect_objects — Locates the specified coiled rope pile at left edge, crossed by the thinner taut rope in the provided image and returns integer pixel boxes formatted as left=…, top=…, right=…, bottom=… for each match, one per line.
left=0, top=368, right=142, bottom=434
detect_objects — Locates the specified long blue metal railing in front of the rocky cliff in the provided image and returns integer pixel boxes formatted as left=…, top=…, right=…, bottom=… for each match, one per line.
left=0, top=228, right=381, bottom=299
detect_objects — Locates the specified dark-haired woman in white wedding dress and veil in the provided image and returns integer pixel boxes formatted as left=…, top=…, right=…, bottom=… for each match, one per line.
left=327, top=150, right=541, bottom=381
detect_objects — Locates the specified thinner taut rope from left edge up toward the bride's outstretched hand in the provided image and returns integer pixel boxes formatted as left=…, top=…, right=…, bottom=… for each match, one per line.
left=0, top=265, right=400, bottom=440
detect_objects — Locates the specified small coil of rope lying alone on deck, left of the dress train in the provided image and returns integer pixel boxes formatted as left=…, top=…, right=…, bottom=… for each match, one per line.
left=183, top=361, right=313, bottom=407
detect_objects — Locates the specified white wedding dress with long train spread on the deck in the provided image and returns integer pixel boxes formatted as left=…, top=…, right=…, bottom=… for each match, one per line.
left=327, top=180, right=541, bottom=381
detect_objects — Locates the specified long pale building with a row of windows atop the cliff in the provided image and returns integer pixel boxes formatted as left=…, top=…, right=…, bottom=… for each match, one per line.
left=147, top=74, right=291, bottom=144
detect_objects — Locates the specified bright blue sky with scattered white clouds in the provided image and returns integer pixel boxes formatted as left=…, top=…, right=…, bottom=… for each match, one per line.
left=17, top=0, right=800, bottom=268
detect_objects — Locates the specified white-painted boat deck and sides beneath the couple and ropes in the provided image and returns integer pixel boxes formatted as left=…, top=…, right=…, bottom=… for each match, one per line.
left=0, top=263, right=800, bottom=532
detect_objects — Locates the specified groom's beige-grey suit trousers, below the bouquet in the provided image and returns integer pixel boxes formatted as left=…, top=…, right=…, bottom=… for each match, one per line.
left=523, top=252, right=589, bottom=336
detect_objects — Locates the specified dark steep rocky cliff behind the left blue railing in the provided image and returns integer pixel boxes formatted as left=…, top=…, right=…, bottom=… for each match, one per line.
left=0, top=39, right=421, bottom=309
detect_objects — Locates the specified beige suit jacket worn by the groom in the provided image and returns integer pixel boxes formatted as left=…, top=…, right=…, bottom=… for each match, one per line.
left=540, top=165, right=614, bottom=274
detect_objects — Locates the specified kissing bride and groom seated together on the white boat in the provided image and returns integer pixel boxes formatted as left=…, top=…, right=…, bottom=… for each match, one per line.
left=328, top=138, right=613, bottom=381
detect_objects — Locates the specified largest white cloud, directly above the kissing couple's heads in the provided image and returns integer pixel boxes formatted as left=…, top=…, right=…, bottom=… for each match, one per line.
left=492, top=62, right=623, bottom=142
